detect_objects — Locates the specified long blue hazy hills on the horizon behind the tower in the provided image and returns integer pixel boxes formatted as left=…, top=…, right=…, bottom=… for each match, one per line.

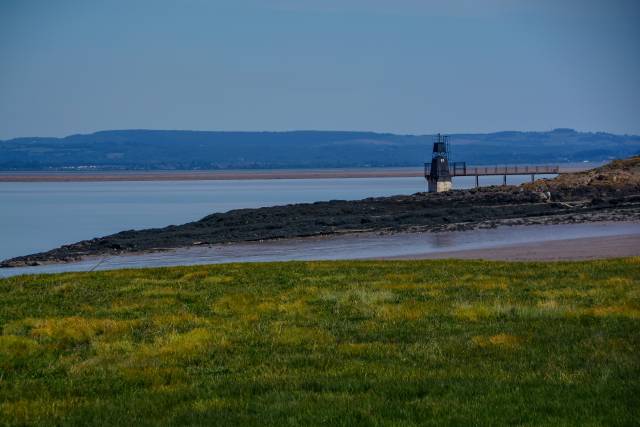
left=0, top=129, right=640, bottom=171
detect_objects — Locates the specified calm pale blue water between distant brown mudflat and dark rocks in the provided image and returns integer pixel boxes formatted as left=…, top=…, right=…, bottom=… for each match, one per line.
left=0, top=176, right=552, bottom=259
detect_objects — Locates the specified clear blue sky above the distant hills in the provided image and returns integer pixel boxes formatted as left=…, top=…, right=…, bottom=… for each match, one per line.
left=0, top=0, right=640, bottom=139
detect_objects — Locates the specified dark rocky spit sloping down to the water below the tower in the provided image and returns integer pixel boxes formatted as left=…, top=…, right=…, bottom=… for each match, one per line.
left=0, top=157, right=640, bottom=267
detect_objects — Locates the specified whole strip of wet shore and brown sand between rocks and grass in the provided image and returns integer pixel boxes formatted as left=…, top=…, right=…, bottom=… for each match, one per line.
left=0, top=221, right=640, bottom=277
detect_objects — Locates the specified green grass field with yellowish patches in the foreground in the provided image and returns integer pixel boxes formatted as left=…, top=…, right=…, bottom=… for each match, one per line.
left=0, top=258, right=640, bottom=426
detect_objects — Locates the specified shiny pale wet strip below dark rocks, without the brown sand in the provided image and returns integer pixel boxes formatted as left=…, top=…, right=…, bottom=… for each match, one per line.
left=0, top=222, right=640, bottom=277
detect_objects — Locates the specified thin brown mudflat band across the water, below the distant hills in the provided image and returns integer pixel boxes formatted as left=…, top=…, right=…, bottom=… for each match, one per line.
left=0, top=163, right=592, bottom=183
